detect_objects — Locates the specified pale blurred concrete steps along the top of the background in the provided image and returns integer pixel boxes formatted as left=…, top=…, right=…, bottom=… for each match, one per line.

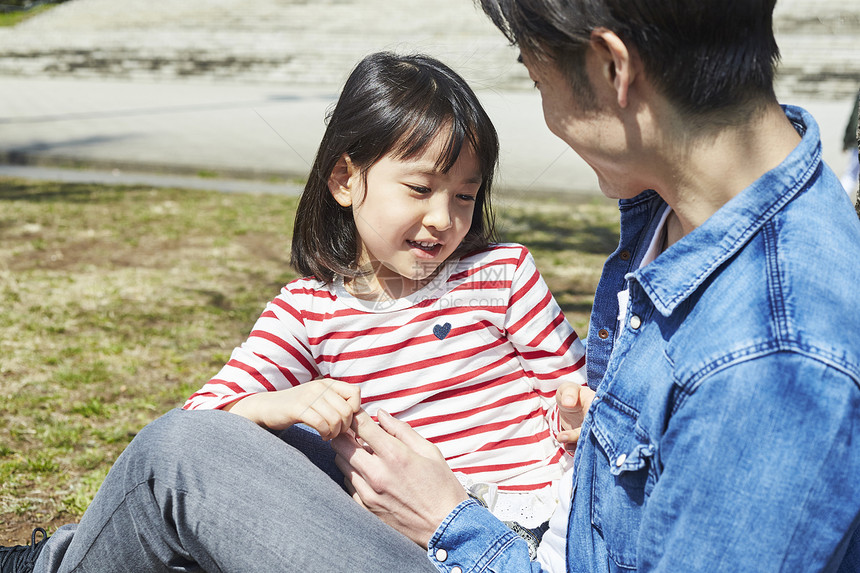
left=0, top=0, right=860, bottom=99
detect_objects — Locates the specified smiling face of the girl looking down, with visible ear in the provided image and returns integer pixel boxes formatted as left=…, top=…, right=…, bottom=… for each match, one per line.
left=329, top=131, right=481, bottom=298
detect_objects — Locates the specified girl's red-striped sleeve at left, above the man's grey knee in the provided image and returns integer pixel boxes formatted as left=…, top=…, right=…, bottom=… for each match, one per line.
left=183, top=282, right=318, bottom=410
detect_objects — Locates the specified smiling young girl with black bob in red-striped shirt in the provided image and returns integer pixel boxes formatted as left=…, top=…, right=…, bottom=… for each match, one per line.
left=185, top=53, right=584, bottom=556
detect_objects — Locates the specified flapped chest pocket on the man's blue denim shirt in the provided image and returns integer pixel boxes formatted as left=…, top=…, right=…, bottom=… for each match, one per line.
left=590, top=394, right=656, bottom=571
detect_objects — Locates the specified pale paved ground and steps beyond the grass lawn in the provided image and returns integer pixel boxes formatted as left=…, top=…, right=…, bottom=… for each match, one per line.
left=0, top=0, right=860, bottom=194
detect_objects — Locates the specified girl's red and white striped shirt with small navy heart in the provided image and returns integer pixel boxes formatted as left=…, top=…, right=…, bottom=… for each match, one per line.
left=185, top=244, right=585, bottom=523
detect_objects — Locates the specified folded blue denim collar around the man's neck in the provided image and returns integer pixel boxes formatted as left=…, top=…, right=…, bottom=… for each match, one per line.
left=626, top=106, right=821, bottom=316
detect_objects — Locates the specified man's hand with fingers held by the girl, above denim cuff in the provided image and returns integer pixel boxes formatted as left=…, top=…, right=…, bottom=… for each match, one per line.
left=332, top=410, right=468, bottom=548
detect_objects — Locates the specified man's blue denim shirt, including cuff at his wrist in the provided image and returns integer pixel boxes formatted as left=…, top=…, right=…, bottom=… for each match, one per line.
left=428, top=107, right=860, bottom=573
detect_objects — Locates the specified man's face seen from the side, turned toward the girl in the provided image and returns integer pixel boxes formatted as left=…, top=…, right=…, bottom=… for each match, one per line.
left=521, top=52, right=642, bottom=198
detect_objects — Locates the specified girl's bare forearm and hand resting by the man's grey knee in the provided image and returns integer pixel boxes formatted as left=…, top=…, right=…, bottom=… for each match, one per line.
left=225, top=378, right=361, bottom=440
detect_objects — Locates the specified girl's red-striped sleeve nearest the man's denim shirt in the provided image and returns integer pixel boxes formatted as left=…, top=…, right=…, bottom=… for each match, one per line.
left=505, top=247, right=586, bottom=437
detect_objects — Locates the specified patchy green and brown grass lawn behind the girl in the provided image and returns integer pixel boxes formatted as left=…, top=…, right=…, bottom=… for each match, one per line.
left=0, top=178, right=618, bottom=545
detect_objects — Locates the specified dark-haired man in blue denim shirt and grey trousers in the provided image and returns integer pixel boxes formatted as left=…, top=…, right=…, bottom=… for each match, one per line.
left=8, top=0, right=860, bottom=573
